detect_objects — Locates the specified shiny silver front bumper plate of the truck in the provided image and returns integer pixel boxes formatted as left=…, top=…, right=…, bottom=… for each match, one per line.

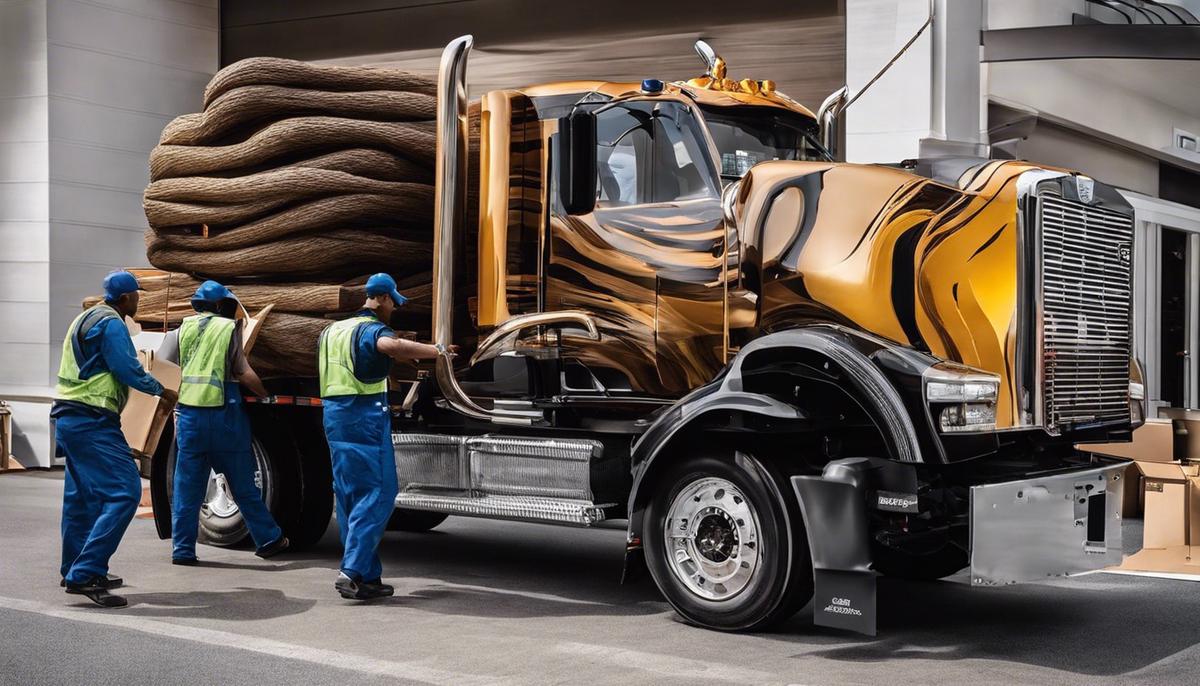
left=971, top=459, right=1128, bottom=586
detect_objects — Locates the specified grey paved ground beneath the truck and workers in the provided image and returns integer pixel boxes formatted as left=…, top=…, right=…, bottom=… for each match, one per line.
left=0, top=473, right=1200, bottom=686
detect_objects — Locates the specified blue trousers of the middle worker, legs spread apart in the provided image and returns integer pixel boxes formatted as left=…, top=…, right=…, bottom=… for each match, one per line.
left=170, top=374, right=283, bottom=559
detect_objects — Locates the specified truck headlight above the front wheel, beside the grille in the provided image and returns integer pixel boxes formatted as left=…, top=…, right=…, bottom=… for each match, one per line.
left=922, top=362, right=1000, bottom=432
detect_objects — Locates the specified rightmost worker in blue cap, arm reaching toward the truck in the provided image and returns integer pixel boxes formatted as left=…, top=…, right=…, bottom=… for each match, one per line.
left=317, top=273, right=452, bottom=600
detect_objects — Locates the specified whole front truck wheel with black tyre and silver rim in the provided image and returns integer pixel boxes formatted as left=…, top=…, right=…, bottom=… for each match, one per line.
left=643, top=455, right=812, bottom=631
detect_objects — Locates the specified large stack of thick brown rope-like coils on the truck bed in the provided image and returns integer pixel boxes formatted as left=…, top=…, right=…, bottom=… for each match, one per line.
left=138, top=58, right=446, bottom=375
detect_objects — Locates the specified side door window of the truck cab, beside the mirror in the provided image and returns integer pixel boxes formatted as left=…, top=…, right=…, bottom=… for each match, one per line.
left=596, top=101, right=718, bottom=207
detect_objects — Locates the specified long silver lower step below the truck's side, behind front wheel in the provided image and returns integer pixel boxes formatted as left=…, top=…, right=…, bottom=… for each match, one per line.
left=396, top=491, right=605, bottom=526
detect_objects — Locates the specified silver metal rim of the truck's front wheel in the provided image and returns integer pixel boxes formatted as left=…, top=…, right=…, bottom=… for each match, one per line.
left=662, top=477, right=761, bottom=601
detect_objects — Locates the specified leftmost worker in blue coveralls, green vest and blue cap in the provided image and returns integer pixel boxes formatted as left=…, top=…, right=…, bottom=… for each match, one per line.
left=50, top=271, right=174, bottom=608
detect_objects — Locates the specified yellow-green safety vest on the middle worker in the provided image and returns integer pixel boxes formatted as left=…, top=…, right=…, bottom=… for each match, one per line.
left=179, top=312, right=236, bottom=408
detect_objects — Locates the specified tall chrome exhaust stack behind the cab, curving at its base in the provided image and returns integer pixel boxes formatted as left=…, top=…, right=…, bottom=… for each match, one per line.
left=433, top=35, right=532, bottom=425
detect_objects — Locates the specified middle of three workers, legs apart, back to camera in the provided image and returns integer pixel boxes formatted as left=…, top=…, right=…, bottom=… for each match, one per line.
left=160, top=281, right=289, bottom=566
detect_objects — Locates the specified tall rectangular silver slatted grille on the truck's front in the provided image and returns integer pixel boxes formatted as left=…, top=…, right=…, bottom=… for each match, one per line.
left=1038, top=194, right=1133, bottom=427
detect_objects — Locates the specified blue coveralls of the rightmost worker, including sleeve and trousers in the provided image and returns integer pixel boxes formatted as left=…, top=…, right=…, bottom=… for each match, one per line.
left=322, top=309, right=400, bottom=582
